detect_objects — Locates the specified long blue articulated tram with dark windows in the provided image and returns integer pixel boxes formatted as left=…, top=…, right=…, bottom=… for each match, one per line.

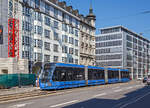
left=39, top=63, right=129, bottom=90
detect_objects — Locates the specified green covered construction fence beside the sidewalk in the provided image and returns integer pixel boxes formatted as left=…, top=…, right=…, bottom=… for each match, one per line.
left=0, top=74, right=36, bottom=88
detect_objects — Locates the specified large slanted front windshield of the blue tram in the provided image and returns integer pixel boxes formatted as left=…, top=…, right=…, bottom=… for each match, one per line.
left=40, top=64, right=53, bottom=82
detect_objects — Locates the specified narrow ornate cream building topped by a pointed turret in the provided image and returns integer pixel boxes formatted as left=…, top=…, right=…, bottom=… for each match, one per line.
left=79, top=7, right=96, bottom=65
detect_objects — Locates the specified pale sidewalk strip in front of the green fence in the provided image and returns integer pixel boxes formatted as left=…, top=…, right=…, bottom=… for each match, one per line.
left=0, top=86, right=40, bottom=96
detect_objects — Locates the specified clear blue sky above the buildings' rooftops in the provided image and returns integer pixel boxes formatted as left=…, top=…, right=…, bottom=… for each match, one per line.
left=60, top=0, right=150, bottom=39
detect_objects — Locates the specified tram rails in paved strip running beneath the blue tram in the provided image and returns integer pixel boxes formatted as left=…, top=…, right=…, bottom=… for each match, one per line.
left=0, top=81, right=138, bottom=103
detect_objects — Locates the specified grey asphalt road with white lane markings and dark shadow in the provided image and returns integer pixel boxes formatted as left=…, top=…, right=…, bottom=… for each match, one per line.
left=0, top=82, right=150, bottom=108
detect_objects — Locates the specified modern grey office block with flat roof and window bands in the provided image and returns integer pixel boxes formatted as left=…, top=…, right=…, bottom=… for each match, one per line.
left=96, top=26, right=150, bottom=79
